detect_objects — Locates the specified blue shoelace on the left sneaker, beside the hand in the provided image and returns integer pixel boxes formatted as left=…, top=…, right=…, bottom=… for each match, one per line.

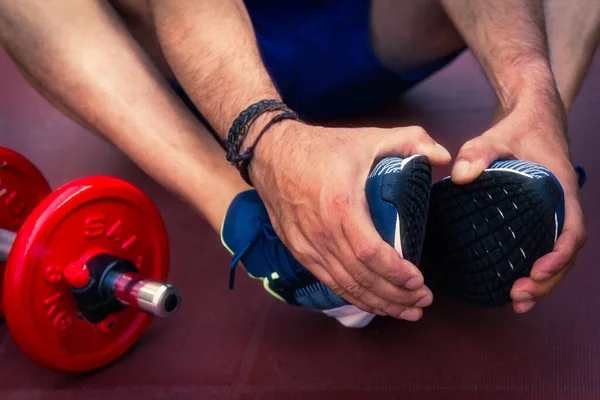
left=229, top=221, right=300, bottom=290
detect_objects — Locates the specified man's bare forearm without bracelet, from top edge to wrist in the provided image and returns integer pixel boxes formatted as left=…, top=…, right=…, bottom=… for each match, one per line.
left=441, top=0, right=560, bottom=112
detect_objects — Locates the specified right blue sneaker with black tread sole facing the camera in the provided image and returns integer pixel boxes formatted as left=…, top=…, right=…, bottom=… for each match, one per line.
left=420, top=160, right=585, bottom=307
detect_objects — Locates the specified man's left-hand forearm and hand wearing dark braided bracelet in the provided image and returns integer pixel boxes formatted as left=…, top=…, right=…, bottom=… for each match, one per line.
left=149, top=0, right=442, bottom=320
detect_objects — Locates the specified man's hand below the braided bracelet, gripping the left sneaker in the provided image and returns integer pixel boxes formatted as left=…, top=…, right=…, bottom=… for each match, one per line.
left=248, top=121, right=451, bottom=321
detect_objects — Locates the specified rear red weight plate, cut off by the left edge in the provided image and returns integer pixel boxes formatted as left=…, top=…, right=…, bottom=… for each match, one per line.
left=0, top=147, right=52, bottom=318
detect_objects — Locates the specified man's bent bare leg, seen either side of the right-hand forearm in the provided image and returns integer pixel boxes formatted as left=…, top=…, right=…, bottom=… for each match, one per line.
left=371, top=0, right=600, bottom=112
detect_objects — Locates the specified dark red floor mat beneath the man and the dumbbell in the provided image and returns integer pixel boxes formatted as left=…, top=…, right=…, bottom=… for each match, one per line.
left=0, top=47, right=600, bottom=400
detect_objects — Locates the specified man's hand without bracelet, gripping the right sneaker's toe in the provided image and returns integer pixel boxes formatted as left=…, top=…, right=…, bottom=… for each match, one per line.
left=452, top=95, right=586, bottom=313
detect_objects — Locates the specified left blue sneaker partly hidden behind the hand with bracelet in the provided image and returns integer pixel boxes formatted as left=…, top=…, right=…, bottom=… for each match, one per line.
left=221, top=156, right=431, bottom=328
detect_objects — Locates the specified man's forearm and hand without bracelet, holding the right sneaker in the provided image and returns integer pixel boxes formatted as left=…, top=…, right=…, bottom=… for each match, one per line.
left=441, top=0, right=586, bottom=313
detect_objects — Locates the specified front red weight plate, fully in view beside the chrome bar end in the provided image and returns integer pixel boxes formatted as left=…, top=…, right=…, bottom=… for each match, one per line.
left=4, top=177, right=169, bottom=372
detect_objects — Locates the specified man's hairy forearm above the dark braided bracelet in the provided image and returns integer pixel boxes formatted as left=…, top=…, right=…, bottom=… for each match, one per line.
left=151, top=0, right=280, bottom=138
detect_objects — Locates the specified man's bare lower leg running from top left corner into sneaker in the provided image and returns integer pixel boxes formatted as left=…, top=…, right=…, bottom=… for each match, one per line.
left=0, top=0, right=246, bottom=228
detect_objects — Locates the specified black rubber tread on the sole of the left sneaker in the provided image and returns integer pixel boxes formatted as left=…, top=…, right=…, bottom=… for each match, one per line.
left=382, top=156, right=431, bottom=266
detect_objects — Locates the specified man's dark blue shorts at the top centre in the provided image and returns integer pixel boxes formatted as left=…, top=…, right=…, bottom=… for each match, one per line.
left=171, top=0, right=460, bottom=120
